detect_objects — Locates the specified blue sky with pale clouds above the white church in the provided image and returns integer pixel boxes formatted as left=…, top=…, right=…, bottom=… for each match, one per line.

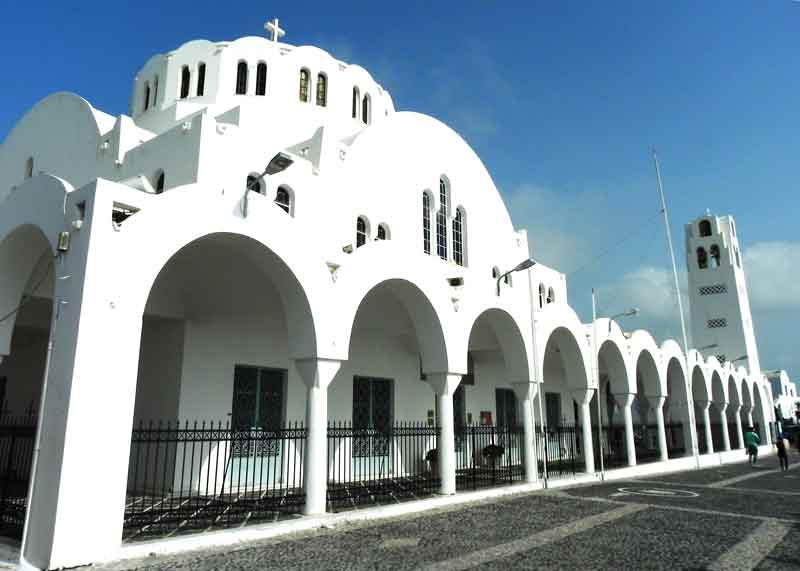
left=0, top=0, right=800, bottom=382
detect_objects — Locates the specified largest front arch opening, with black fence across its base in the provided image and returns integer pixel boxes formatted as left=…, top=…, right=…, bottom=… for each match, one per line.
left=123, top=233, right=313, bottom=541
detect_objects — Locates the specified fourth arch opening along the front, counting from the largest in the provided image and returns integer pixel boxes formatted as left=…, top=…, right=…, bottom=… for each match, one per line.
left=540, top=327, right=594, bottom=478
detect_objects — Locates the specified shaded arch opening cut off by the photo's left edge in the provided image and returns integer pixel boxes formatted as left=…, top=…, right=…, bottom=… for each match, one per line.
left=0, top=225, right=57, bottom=540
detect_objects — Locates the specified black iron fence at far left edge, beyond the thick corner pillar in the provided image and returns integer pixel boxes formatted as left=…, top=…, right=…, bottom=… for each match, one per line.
left=0, top=415, right=37, bottom=539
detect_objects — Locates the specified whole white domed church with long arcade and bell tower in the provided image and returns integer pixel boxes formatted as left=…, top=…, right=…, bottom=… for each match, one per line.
left=0, top=21, right=774, bottom=569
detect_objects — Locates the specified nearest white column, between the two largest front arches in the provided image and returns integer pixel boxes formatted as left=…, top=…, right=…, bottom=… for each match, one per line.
left=294, top=358, right=342, bottom=515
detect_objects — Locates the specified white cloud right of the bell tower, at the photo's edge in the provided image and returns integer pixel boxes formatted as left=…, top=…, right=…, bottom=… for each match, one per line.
left=743, top=242, right=800, bottom=310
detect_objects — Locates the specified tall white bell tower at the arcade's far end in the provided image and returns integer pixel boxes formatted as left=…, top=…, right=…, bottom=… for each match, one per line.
left=686, top=211, right=761, bottom=374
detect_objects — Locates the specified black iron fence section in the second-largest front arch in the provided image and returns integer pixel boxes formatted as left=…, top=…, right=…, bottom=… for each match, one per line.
left=327, top=421, right=440, bottom=511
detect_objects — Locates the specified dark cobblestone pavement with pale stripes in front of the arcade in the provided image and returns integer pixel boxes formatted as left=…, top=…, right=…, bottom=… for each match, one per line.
left=98, top=457, right=800, bottom=571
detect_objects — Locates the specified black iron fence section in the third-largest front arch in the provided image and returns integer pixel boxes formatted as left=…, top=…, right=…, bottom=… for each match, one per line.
left=456, top=425, right=525, bottom=490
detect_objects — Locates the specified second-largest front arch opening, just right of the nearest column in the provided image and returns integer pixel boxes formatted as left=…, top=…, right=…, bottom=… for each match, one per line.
left=328, top=279, right=455, bottom=511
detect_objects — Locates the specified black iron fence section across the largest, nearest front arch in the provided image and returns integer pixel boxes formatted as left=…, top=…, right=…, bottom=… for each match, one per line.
left=123, top=422, right=306, bottom=541
